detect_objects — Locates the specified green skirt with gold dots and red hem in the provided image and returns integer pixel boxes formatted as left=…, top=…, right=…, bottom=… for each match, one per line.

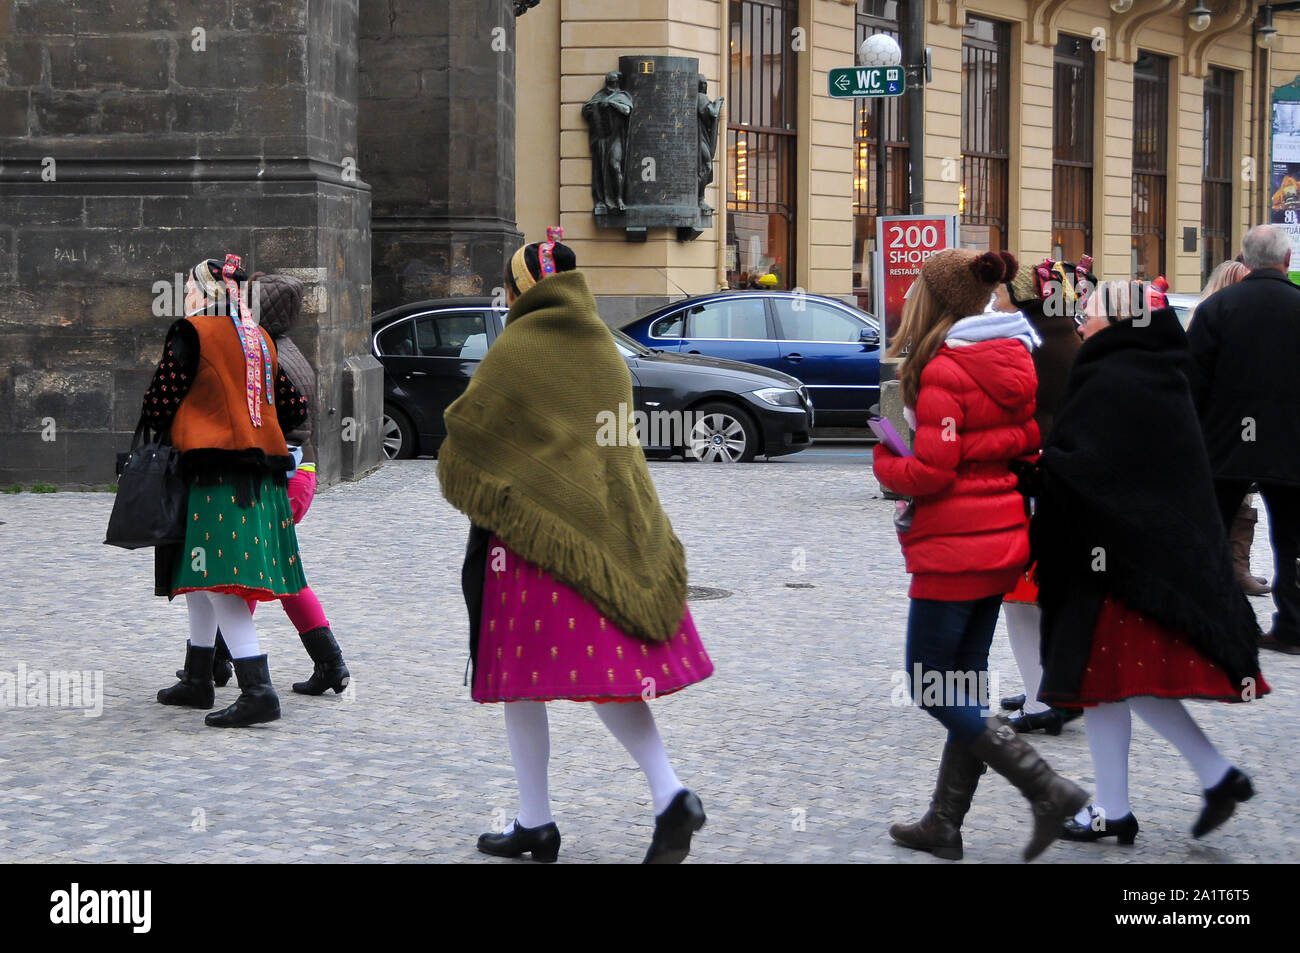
left=172, top=476, right=307, bottom=602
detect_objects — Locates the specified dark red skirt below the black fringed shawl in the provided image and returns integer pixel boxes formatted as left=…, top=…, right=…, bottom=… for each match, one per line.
left=1043, top=598, right=1269, bottom=707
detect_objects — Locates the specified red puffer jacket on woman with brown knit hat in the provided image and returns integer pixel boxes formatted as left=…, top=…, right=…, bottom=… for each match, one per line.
left=875, top=338, right=1039, bottom=602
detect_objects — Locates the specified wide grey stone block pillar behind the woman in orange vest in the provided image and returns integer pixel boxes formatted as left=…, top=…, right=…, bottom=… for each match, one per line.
left=0, top=0, right=382, bottom=485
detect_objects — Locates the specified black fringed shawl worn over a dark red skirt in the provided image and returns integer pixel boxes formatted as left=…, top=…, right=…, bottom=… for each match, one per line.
left=1030, top=308, right=1260, bottom=702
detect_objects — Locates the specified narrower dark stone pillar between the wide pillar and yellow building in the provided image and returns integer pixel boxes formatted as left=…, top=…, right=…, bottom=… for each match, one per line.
left=358, top=0, right=522, bottom=312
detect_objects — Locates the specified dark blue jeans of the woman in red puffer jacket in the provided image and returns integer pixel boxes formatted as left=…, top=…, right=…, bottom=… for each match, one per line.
left=907, top=595, right=1002, bottom=745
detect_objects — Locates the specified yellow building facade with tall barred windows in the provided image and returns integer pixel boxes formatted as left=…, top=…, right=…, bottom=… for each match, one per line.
left=516, top=0, right=1300, bottom=325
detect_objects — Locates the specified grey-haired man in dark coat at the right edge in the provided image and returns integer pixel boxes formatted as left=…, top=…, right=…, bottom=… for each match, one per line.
left=1187, top=225, right=1300, bottom=655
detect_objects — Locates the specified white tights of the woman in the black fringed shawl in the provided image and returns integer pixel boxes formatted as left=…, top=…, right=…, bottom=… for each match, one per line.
left=1080, top=696, right=1232, bottom=823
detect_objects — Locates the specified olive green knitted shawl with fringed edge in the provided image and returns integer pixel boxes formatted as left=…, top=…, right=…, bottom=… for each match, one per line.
left=438, top=272, right=686, bottom=642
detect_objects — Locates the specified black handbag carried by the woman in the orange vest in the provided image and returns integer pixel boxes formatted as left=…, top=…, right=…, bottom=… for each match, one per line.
left=104, top=416, right=190, bottom=549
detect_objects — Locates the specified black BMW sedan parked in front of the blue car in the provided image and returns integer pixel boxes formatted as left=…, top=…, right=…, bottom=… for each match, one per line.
left=371, top=298, right=813, bottom=463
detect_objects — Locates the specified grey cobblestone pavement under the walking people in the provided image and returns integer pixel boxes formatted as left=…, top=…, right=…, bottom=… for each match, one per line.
left=0, top=458, right=1300, bottom=863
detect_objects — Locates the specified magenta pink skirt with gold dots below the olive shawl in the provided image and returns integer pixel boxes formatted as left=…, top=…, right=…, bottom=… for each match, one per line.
left=473, top=537, right=714, bottom=702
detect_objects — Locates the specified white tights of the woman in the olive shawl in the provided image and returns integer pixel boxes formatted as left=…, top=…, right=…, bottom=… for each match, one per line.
left=499, top=696, right=683, bottom=831
